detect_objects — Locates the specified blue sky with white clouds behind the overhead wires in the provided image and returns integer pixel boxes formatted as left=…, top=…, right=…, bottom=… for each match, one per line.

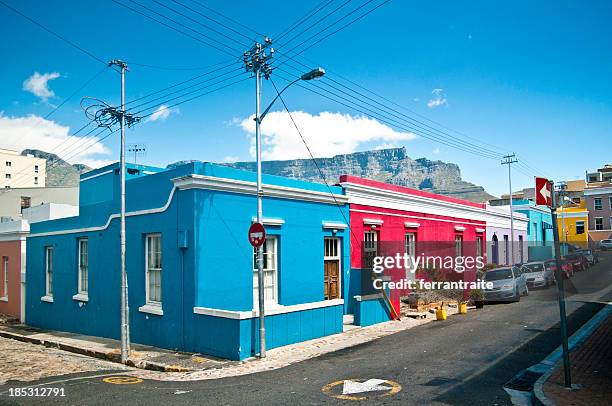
left=0, top=0, right=612, bottom=194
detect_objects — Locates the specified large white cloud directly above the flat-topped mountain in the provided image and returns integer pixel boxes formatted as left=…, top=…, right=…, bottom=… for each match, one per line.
left=240, top=111, right=416, bottom=163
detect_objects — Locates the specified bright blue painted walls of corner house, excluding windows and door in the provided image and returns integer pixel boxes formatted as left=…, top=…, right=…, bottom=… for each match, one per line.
left=26, top=163, right=350, bottom=359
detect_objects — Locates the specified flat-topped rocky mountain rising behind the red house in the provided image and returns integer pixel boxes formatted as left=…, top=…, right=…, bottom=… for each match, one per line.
left=224, top=148, right=495, bottom=202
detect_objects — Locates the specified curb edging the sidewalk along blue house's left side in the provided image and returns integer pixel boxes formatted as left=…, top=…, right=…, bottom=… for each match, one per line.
left=0, top=329, right=191, bottom=372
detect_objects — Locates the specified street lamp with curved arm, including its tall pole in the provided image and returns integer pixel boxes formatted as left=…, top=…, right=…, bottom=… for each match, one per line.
left=250, top=64, right=325, bottom=358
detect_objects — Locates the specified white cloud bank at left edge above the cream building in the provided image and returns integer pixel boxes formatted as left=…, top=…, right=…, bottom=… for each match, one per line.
left=0, top=112, right=111, bottom=167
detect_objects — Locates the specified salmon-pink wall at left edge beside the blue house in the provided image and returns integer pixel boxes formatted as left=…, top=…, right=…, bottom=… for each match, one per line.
left=0, top=240, right=21, bottom=318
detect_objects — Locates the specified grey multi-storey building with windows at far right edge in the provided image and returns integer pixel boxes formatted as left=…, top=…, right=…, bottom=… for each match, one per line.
left=584, top=164, right=612, bottom=242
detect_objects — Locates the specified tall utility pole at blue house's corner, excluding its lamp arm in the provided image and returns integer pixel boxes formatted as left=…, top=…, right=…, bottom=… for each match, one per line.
left=243, top=37, right=274, bottom=358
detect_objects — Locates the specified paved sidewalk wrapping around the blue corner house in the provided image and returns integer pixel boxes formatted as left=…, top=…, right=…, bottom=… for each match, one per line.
left=0, top=307, right=460, bottom=381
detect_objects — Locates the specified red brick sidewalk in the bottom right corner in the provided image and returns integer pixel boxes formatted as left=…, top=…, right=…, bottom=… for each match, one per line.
left=543, top=314, right=612, bottom=406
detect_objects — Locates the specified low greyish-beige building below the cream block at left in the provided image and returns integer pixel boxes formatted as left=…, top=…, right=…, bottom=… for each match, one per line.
left=0, top=187, right=79, bottom=222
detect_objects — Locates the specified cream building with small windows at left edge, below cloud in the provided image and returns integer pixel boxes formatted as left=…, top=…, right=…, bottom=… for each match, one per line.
left=0, top=149, right=47, bottom=189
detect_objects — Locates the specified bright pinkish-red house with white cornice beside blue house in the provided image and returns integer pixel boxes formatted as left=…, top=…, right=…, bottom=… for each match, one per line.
left=340, top=175, right=486, bottom=320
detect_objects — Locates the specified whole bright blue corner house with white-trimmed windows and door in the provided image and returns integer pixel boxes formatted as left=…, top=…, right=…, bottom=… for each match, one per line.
left=26, top=162, right=350, bottom=360
